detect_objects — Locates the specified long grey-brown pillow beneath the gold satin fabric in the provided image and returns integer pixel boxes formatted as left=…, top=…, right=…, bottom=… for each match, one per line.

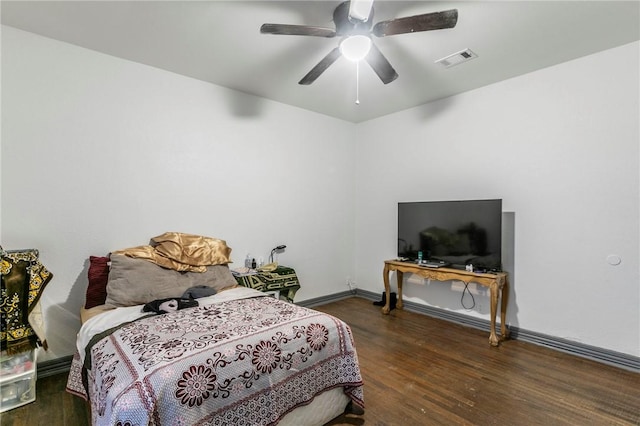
left=106, top=253, right=237, bottom=306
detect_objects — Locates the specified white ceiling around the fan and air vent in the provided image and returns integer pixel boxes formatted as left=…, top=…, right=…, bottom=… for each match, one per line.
left=1, top=0, right=640, bottom=122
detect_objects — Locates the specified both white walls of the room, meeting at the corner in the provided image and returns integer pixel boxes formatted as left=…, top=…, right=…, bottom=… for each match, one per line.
left=0, top=27, right=640, bottom=360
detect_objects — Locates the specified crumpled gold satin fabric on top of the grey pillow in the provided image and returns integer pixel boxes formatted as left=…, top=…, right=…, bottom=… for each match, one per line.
left=113, top=232, right=231, bottom=272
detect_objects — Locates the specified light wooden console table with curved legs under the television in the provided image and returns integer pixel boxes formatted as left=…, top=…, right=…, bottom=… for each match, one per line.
left=382, top=260, right=509, bottom=346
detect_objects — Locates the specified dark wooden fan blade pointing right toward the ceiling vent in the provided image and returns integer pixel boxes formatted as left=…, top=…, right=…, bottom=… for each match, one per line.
left=372, top=9, right=458, bottom=37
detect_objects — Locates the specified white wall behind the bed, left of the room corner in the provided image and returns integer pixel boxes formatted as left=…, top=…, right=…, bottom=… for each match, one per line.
left=1, top=27, right=355, bottom=361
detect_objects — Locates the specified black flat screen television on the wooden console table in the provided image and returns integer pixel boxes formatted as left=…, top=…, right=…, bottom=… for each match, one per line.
left=398, top=199, right=502, bottom=271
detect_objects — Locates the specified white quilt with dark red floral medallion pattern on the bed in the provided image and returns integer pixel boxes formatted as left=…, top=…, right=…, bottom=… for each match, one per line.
left=67, top=297, right=364, bottom=426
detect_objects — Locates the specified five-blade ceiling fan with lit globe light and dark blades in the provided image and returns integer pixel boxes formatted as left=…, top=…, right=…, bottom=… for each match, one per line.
left=260, top=0, right=458, bottom=85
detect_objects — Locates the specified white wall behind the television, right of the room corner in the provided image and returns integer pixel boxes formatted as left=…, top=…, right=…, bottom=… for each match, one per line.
left=356, top=42, right=640, bottom=356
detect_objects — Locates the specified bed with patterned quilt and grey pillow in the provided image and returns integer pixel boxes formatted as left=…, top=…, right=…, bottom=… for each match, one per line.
left=67, top=235, right=364, bottom=426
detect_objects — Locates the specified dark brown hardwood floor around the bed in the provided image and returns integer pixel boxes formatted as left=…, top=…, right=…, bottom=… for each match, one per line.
left=0, top=298, right=640, bottom=426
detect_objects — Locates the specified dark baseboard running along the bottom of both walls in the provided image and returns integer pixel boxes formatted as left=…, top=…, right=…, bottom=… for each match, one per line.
left=38, top=289, right=640, bottom=377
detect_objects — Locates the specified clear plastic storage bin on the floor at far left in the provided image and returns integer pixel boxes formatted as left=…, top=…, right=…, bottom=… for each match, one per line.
left=0, top=350, right=36, bottom=413
